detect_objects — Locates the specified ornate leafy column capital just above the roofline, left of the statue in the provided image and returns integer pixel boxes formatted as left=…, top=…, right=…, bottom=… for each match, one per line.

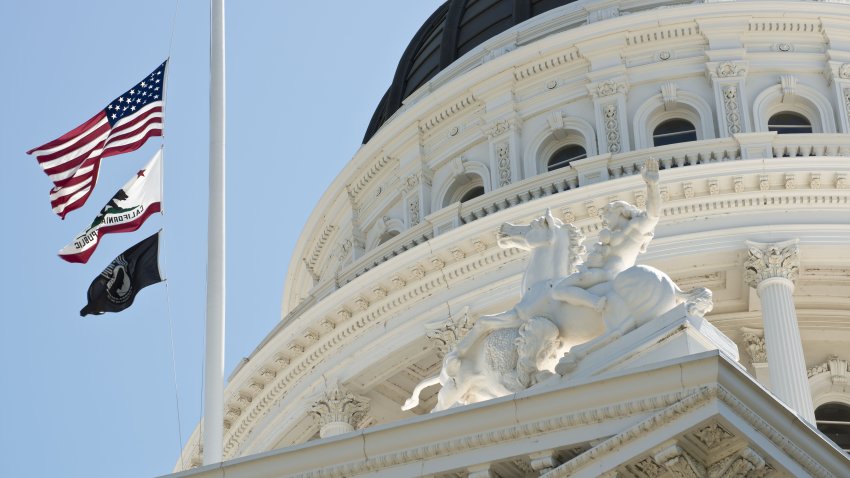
left=308, top=384, right=369, bottom=438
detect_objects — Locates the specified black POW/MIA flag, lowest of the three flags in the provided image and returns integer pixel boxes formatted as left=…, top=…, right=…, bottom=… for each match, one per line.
left=80, top=232, right=162, bottom=317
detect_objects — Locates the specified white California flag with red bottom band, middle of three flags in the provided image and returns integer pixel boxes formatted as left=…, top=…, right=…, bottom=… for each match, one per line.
left=59, top=148, right=162, bottom=264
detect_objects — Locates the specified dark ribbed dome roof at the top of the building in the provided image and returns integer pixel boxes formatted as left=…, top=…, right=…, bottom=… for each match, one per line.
left=363, top=0, right=575, bottom=143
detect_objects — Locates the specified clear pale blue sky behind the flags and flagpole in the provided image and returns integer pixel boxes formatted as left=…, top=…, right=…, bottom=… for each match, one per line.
left=0, top=0, right=442, bottom=478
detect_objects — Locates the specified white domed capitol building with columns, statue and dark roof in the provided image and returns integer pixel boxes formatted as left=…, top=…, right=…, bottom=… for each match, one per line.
left=174, top=0, right=850, bottom=478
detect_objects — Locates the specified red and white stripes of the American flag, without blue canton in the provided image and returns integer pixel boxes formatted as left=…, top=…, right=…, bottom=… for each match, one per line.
left=27, top=100, right=162, bottom=219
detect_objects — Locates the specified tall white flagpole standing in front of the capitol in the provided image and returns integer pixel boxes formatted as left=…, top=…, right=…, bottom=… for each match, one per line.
left=203, top=0, right=225, bottom=465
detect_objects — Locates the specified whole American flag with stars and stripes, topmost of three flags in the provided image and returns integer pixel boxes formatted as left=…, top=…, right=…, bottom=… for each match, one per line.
left=27, top=60, right=168, bottom=219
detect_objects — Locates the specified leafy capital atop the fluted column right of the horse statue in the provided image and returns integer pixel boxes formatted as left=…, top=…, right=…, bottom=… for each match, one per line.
left=744, top=239, right=800, bottom=289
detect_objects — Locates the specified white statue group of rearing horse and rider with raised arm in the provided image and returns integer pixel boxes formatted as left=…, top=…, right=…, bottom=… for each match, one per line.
left=403, top=159, right=712, bottom=411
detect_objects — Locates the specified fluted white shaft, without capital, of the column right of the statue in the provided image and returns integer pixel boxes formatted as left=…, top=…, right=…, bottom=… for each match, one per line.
left=757, top=277, right=815, bottom=423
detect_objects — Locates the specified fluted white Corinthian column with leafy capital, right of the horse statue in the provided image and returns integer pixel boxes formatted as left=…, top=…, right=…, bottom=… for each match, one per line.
left=744, top=239, right=815, bottom=423
